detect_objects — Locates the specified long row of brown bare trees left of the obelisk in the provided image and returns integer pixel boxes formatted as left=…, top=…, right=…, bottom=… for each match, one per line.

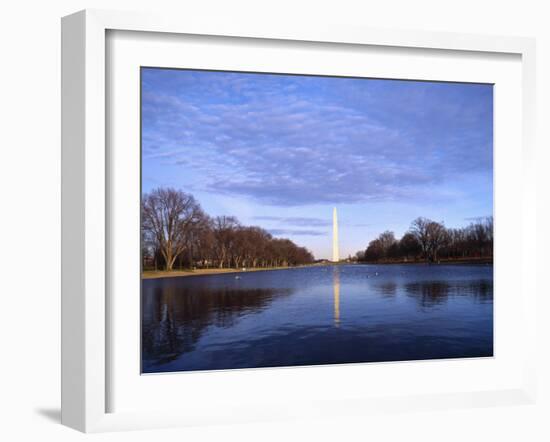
left=141, top=188, right=314, bottom=270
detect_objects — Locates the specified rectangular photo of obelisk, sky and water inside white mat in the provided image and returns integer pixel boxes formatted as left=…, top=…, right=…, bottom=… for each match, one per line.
left=140, top=66, right=498, bottom=374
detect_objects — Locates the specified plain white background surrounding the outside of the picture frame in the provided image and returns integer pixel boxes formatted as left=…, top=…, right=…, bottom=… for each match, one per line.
left=0, top=0, right=550, bottom=441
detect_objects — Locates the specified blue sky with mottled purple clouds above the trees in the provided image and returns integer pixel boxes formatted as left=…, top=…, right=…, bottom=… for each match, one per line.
left=141, top=68, right=493, bottom=259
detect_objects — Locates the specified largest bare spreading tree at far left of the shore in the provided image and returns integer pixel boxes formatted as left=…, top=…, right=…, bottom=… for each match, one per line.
left=141, top=188, right=204, bottom=270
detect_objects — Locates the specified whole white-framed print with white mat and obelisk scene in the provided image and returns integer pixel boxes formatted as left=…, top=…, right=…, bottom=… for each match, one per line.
left=62, top=11, right=536, bottom=431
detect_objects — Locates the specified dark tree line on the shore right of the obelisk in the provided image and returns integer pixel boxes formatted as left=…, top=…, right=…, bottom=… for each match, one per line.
left=356, top=216, right=493, bottom=262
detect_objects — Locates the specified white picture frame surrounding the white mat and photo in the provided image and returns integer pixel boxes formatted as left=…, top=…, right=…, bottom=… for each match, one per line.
left=62, top=10, right=537, bottom=432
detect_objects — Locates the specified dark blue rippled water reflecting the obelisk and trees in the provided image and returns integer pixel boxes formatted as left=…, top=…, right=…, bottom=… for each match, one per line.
left=142, top=264, right=493, bottom=373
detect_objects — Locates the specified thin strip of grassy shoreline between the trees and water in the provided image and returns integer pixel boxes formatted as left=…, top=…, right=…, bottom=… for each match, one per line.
left=141, top=258, right=493, bottom=279
